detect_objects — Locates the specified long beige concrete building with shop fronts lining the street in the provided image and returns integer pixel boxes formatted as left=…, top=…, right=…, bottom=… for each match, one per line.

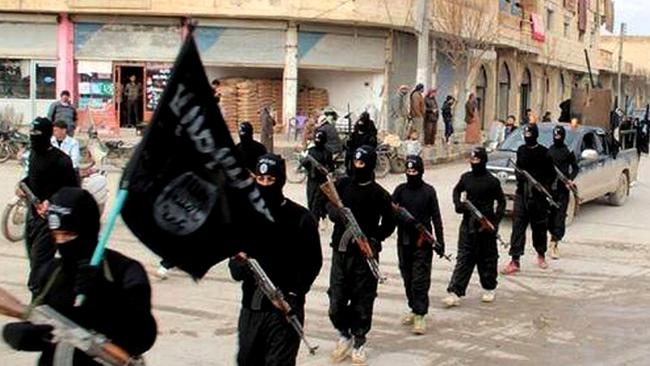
left=0, top=0, right=644, bottom=132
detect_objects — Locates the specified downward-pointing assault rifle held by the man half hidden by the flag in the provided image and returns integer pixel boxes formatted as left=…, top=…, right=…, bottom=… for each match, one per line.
left=235, top=255, right=318, bottom=355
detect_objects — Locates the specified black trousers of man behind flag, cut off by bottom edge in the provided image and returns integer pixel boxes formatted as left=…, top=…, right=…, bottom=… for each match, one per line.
left=237, top=308, right=304, bottom=366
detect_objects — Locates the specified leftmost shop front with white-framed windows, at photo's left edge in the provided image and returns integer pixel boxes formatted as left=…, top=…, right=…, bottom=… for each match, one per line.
left=0, top=14, right=57, bottom=124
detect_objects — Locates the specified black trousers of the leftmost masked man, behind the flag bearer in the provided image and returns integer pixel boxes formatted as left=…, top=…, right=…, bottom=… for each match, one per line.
left=25, top=209, right=56, bottom=293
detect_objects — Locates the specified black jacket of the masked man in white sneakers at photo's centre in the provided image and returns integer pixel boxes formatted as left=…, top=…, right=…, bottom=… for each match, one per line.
left=328, top=177, right=396, bottom=254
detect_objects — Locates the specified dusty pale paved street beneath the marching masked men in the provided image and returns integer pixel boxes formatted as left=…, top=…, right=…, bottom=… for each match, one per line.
left=0, top=160, right=650, bottom=366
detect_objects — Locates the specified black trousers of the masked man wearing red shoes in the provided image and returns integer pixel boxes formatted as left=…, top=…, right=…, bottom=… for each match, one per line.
left=510, top=192, right=548, bottom=260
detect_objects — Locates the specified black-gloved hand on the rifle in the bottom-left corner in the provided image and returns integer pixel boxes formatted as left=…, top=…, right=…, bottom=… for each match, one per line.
left=2, top=322, right=54, bottom=352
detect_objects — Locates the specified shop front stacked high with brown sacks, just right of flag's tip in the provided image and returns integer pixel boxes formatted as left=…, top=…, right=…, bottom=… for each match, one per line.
left=195, top=19, right=286, bottom=133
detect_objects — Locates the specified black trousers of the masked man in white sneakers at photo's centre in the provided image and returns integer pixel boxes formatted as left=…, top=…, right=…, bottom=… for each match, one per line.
left=327, top=250, right=377, bottom=347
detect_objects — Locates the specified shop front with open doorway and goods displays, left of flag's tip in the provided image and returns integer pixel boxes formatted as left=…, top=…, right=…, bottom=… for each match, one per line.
left=73, top=17, right=182, bottom=135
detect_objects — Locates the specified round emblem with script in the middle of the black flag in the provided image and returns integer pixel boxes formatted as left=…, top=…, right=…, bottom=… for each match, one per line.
left=153, top=172, right=218, bottom=236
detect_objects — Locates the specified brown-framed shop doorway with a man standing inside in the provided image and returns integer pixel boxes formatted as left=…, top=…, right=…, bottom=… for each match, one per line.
left=113, top=64, right=145, bottom=128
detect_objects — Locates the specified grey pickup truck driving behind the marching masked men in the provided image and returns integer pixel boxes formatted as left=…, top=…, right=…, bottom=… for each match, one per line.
left=487, top=123, right=639, bottom=224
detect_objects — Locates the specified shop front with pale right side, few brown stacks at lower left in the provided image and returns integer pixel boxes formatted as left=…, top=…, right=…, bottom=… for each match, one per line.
left=298, top=24, right=388, bottom=125
